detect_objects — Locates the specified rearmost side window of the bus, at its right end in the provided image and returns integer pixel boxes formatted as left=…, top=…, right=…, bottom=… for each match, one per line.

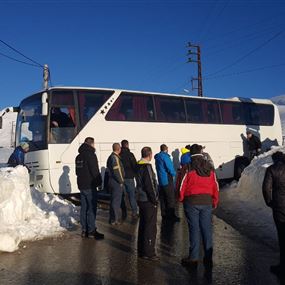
left=245, top=103, right=274, bottom=126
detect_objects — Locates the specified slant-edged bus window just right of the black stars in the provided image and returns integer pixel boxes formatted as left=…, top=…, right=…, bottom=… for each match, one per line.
left=106, top=93, right=154, bottom=122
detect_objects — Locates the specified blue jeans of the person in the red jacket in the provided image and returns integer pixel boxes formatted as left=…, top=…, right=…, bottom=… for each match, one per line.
left=183, top=201, right=213, bottom=260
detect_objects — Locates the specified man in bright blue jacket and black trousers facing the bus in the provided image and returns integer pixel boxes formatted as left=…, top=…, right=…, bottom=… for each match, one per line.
left=154, top=144, right=180, bottom=222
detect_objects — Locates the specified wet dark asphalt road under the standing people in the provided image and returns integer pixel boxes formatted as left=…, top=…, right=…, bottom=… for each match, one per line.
left=0, top=204, right=279, bottom=285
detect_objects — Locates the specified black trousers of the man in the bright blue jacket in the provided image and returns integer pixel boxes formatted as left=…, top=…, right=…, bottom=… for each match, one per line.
left=159, top=183, right=175, bottom=218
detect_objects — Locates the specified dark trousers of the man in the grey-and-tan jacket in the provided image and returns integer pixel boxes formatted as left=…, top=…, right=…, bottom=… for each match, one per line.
left=109, top=178, right=124, bottom=223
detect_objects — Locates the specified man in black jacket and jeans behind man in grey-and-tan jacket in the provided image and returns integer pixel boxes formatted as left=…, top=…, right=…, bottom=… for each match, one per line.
left=120, top=140, right=138, bottom=218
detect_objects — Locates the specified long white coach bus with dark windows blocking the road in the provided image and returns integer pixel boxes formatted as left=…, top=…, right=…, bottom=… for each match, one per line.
left=5, top=87, right=282, bottom=194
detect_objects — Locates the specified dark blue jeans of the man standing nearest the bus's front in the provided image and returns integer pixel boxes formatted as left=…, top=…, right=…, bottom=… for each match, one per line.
left=80, top=189, right=97, bottom=233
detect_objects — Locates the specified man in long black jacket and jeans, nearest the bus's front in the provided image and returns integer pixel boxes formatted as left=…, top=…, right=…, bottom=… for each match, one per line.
left=75, top=137, right=104, bottom=239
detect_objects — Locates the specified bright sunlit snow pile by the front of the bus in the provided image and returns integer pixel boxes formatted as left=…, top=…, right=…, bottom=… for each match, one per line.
left=0, top=166, right=79, bottom=252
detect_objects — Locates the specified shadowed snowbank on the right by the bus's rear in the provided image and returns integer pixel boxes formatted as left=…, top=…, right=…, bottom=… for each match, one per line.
left=220, top=147, right=285, bottom=246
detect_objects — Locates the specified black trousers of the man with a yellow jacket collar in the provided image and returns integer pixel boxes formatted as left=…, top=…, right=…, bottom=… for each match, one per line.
left=138, top=202, right=157, bottom=257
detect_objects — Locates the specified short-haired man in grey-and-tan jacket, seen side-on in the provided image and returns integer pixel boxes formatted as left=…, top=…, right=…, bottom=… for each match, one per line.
left=107, top=143, right=125, bottom=225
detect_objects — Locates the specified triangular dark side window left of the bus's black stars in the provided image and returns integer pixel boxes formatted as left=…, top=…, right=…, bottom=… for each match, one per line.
left=78, top=90, right=114, bottom=128
